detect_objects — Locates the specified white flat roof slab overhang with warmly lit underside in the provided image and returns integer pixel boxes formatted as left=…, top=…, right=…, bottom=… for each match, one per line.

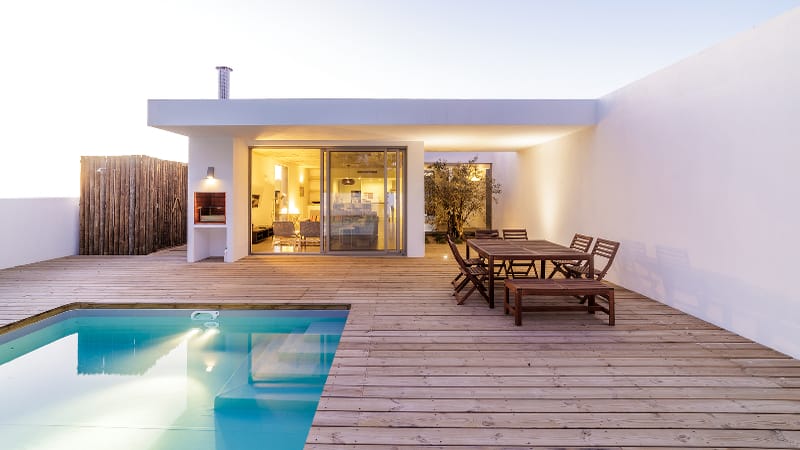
left=147, top=99, right=597, bottom=151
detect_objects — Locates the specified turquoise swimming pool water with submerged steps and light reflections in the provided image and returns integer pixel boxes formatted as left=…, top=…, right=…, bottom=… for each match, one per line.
left=0, top=309, right=347, bottom=450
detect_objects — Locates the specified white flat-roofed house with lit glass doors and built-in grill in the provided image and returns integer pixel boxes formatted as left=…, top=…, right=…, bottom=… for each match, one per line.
left=148, top=98, right=597, bottom=262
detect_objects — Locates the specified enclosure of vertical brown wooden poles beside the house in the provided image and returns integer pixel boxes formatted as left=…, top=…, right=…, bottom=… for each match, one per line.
left=80, top=155, right=188, bottom=255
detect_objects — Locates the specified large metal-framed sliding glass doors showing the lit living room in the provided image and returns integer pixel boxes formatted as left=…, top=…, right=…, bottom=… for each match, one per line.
left=250, top=147, right=405, bottom=254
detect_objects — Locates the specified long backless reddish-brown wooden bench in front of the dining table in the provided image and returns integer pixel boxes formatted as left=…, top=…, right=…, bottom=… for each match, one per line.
left=503, top=278, right=614, bottom=326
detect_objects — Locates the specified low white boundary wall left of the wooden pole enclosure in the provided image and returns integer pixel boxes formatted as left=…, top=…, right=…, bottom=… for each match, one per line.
left=0, top=198, right=80, bottom=269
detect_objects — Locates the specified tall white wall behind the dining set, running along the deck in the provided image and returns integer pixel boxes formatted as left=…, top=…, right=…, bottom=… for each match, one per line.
left=514, top=9, right=800, bottom=357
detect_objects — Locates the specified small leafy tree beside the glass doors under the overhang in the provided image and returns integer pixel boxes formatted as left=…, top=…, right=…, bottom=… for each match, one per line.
left=425, top=158, right=502, bottom=239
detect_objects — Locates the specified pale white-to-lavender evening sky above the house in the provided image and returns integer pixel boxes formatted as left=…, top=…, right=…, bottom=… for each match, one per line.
left=0, top=0, right=800, bottom=198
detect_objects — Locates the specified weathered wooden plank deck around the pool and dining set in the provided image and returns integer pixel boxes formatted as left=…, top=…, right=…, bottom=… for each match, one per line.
left=0, top=245, right=800, bottom=450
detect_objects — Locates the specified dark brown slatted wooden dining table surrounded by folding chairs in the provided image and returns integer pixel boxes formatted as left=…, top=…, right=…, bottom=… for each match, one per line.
left=467, top=239, right=594, bottom=308
